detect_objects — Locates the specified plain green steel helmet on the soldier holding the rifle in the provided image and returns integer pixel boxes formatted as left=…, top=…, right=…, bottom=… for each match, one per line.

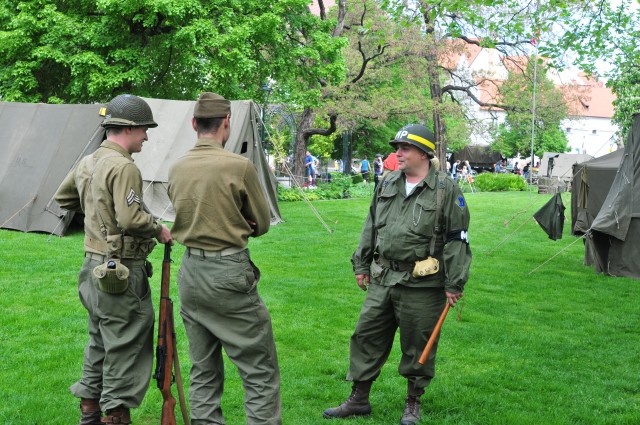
left=102, top=94, right=158, bottom=128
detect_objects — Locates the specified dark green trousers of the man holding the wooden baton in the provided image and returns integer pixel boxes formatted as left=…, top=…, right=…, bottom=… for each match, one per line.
left=348, top=284, right=447, bottom=388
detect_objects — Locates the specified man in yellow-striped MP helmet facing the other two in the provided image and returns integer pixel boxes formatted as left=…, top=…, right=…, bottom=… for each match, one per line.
left=324, top=124, right=471, bottom=425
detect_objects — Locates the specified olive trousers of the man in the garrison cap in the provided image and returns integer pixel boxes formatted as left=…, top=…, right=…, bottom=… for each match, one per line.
left=178, top=250, right=282, bottom=425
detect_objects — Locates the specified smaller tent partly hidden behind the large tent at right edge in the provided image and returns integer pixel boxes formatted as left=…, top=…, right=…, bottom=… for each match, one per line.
left=571, top=148, right=624, bottom=235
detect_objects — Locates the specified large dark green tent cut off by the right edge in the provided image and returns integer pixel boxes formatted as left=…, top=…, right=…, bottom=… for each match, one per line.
left=585, top=114, right=640, bottom=279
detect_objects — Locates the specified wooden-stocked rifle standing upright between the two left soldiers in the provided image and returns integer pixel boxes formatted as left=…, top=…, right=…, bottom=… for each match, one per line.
left=153, top=244, right=189, bottom=425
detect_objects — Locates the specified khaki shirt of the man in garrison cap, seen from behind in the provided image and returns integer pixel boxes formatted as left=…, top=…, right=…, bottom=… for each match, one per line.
left=169, top=138, right=271, bottom=251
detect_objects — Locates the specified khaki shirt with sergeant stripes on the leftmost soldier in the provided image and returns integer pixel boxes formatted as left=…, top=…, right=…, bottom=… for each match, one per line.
left=54, top=140, right=162, bottom=259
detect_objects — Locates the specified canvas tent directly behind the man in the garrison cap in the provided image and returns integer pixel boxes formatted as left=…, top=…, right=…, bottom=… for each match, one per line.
left=133, top=98, right=282, bottom=223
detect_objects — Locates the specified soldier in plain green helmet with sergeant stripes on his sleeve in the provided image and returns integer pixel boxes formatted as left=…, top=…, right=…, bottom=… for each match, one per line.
left=55, top=94, right=173, bottom=425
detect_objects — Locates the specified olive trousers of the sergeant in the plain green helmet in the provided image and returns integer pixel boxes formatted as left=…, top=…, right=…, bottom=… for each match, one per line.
left=70, top=253, right=154, bottom=410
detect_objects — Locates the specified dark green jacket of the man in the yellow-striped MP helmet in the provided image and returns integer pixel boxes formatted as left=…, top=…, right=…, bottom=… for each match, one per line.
left=351, top=167, right=471, bottom=293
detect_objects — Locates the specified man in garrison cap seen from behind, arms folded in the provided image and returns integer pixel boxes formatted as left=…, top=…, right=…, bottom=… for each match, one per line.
left=169, top=93, right=282, bottom=425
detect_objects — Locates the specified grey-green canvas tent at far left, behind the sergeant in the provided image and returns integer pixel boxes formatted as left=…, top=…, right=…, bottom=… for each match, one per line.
left=0, top=102, right=104, bottom=236
